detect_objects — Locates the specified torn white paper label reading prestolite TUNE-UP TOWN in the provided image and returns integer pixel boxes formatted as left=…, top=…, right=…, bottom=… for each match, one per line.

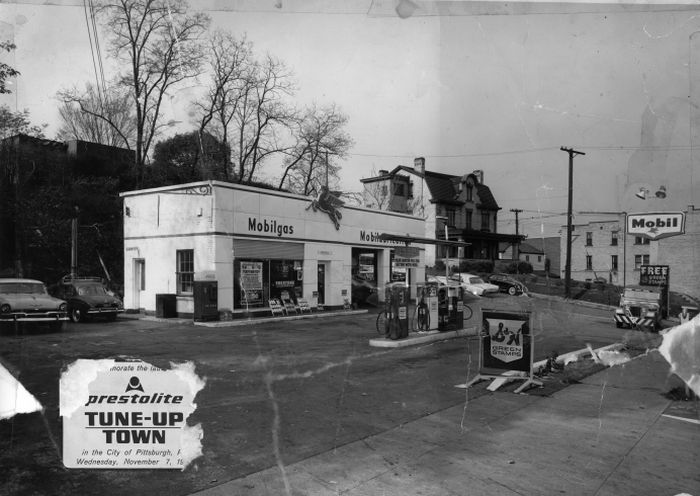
left=60, top=359, right=206, bottom=470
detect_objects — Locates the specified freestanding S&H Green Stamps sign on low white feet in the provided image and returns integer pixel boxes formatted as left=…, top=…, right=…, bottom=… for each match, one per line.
left=466, top=309, right=542, bottom=393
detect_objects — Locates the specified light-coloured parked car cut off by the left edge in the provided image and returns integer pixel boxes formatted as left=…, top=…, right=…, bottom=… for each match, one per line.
left=0, top=279, right=68, bottom=330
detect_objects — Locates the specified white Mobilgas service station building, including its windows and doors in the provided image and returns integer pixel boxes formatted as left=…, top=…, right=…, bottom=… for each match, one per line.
left=121, top=181, right=425, bottom=315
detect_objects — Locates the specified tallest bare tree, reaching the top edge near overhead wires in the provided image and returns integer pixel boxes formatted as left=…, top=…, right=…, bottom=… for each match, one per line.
left=63, top=0, right=209, bottom=182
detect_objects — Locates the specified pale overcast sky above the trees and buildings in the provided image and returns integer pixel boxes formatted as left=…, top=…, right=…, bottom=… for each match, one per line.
left=0, top=0, right=700, bottom=236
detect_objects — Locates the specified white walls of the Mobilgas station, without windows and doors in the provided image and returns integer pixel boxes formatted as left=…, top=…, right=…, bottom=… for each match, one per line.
left=122, top=181, right=425, bottom=313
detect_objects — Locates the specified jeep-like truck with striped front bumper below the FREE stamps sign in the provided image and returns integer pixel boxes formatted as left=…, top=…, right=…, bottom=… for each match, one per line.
left=615, top=286, right=666, bottom=331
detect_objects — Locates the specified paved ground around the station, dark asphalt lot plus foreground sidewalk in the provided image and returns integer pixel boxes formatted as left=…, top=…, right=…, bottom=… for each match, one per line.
left=0, top=297, right=700, bottom=496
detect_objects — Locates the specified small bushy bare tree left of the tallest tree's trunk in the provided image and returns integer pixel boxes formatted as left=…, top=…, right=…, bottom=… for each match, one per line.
left=56, top=83, right=136, bottom=149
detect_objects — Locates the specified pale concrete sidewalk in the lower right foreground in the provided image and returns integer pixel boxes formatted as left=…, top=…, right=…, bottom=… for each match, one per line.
left=191, top=352, right=700, bottom=496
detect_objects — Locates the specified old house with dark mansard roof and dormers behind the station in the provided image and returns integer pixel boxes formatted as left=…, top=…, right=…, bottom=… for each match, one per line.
left=361, top=157, right=523, bottom=266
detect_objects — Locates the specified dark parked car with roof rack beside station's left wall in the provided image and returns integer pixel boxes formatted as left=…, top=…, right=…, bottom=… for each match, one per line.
left=51, top=276, right=124, bottom=322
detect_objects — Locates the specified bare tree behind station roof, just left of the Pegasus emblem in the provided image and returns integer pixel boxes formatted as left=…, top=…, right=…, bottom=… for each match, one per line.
left=279, top=104, right=353, bottom=195
